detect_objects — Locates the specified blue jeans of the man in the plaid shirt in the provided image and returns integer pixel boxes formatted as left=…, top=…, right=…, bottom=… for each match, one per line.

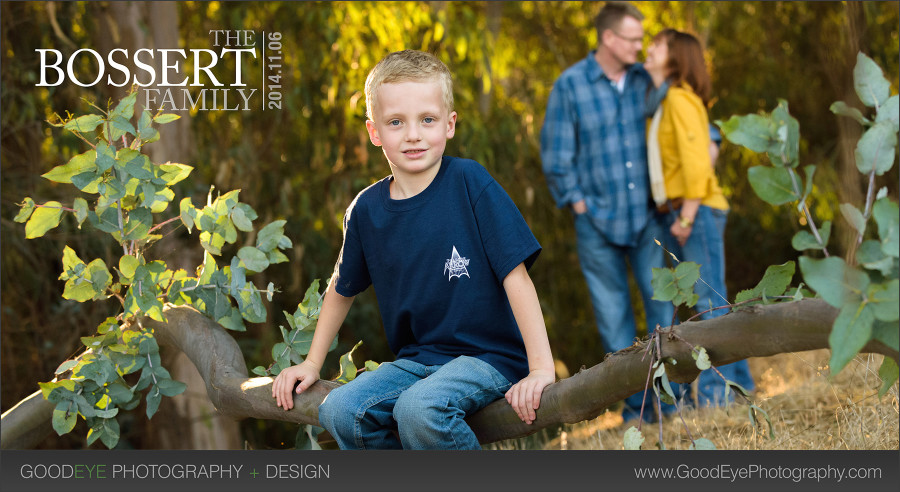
left=575, top=214, right=678, bottom=419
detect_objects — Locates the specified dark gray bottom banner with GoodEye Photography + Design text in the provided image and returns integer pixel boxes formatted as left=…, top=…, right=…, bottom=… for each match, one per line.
left=0, top=451, right=900, bottom=492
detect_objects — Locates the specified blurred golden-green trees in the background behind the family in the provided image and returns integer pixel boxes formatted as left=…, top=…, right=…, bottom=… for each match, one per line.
left=0, top=1, right=900, bottom=448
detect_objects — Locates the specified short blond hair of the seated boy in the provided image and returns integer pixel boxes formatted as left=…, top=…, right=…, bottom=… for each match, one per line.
left=366, top=50, right=453, bottom=120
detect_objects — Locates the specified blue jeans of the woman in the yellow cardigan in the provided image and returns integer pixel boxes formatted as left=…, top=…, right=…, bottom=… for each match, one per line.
left=665, top=205, right=754, bottom=406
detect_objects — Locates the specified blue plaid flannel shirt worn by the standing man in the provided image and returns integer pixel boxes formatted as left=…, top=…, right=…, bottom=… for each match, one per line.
left=541, top=51, right=668, bottom=246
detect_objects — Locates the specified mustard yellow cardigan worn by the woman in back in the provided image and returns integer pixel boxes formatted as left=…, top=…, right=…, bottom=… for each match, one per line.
left=648, top=83, right=728, bottom=210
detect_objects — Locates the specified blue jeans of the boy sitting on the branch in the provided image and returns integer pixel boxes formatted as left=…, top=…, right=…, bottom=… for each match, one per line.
left=319, top=356, right=512, bottom=449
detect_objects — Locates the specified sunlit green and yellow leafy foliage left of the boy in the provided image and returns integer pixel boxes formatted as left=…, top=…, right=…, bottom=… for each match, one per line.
left=15, top=92, right=321, bottom=448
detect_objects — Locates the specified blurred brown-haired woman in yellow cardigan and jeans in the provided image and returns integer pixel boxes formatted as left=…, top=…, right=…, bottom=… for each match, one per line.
left=644, top=29, right=754, bottom=406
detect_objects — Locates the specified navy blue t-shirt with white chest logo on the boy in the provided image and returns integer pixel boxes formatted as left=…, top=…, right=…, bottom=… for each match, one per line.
left=333, top=156, right=541, bottom=383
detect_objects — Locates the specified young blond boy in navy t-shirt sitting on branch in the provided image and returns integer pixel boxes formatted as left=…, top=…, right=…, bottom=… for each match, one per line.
left=272, top=50, right=554, bottom=449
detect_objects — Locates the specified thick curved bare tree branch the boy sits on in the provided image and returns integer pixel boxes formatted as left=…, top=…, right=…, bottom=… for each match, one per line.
left=0, top=300, right=900, bottom=449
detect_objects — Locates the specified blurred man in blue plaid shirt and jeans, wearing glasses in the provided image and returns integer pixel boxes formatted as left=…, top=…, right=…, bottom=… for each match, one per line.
left=541, top=2, right=673, bottom=420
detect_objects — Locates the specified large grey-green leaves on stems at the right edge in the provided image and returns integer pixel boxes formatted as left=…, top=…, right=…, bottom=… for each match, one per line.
left=719, top=53, right=900, bottom=384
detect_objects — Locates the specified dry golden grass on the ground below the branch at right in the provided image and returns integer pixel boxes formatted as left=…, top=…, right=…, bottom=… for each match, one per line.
left=492, top=350, right=900, bottom=450
